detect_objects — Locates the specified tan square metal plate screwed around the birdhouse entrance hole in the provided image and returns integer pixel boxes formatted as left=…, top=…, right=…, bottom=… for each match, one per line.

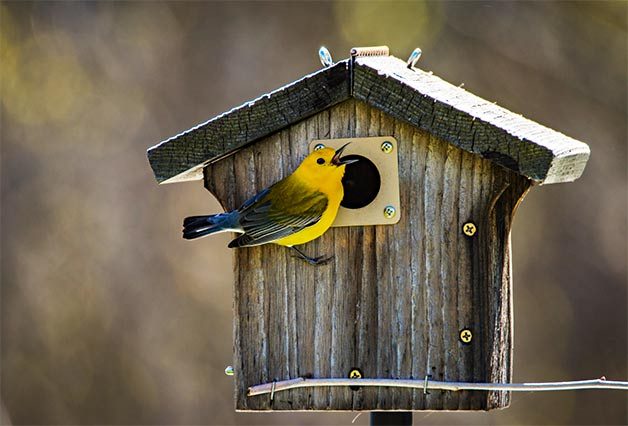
left=309, top=136, right=401, bottom=226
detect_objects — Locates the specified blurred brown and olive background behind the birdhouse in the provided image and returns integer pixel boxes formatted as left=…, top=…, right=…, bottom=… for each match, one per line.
left=0, top=1, right=628, bottom=425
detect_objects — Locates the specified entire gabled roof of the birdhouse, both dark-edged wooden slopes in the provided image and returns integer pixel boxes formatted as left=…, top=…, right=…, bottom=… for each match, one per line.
left=148, top=52, right=590, bottom=184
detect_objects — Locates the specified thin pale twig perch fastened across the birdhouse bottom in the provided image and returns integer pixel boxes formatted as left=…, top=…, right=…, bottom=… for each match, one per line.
left=247, top=376, right=628, bottom=397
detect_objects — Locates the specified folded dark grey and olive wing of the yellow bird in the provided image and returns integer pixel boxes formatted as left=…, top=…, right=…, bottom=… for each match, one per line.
left=229, top=188, right=327, bottom=247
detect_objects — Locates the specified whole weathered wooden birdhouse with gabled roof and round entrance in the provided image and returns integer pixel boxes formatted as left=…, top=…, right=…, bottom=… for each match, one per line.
left=148, top=48, right=589, bottom=411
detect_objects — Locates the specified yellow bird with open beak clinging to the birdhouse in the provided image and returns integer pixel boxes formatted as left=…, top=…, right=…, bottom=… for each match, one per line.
left=183, top=143, right=357, bottom=265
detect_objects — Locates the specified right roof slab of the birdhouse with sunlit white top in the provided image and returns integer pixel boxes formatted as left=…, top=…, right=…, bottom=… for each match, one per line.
left=352, top=56, right=590, bottom=184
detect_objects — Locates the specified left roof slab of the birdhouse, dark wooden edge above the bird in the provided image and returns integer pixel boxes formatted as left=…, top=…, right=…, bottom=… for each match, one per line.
left=147, top=61, right=350, bottom=183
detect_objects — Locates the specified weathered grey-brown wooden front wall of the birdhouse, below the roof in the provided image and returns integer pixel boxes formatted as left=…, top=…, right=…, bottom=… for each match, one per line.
left=205, top=100, right=531, bottom=410
